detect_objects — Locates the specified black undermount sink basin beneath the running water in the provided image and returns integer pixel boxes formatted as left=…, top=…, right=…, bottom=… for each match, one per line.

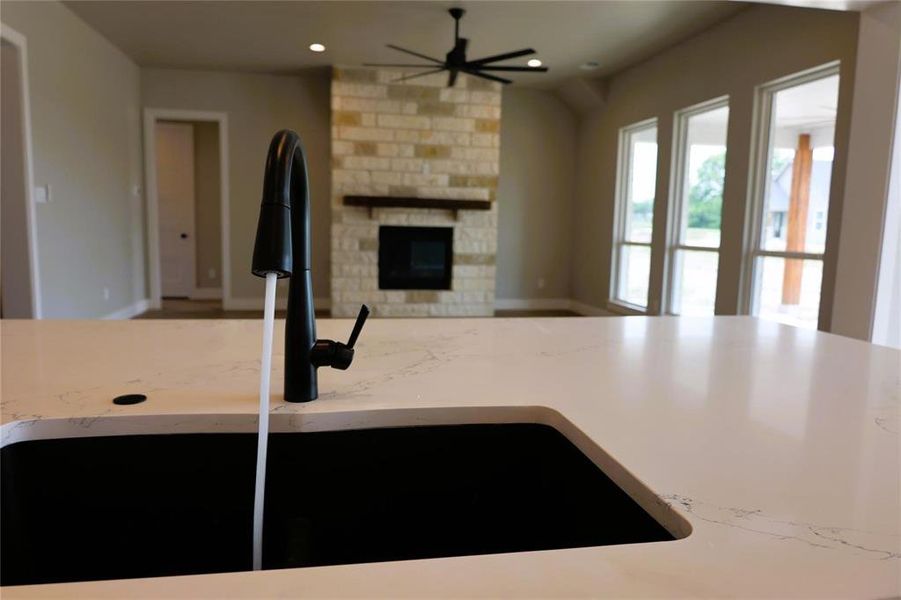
left=0, top=424, right=674, bottom=585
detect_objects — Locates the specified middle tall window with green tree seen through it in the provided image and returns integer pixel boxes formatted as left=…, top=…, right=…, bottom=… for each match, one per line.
left=667, top=99, right=729, bottom=315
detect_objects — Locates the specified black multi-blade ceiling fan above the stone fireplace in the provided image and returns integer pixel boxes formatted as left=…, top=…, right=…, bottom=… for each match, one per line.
left=364, top=8, right=547, bottom=87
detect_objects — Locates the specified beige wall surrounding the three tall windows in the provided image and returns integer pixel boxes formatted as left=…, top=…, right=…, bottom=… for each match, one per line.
left=573, top=5, right=858, bottom=327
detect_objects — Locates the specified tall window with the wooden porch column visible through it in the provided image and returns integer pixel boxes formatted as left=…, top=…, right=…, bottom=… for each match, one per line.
left=748, top=65, right=839, bottom=328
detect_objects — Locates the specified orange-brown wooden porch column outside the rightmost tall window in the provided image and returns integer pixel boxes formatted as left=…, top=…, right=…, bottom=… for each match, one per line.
left=782, top=133, right=813, bottom=304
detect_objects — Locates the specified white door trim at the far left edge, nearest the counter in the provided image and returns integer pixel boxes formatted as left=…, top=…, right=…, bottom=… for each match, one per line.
left=0, top=23, right=43, bottom=319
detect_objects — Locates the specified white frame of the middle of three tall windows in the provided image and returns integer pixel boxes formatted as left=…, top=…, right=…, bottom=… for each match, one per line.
left=663, top=95, right=731, bottom=316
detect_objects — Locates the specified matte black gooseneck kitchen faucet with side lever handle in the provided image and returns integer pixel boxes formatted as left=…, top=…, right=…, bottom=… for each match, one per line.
left=251, top=129, right=369, bottom=402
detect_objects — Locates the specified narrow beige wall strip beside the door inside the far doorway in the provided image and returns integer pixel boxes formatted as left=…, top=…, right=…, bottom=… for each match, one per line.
left=193, top=121, right=222, bottom=288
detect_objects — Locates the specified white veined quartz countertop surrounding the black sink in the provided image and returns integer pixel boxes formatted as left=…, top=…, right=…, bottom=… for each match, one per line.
left=0, top=317, right=901, bottom=599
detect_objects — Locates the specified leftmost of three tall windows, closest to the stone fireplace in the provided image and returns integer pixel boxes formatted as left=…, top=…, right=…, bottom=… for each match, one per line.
left=611, top=119, right=657, bottom=312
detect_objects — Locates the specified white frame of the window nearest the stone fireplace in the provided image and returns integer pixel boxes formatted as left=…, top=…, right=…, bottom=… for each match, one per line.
left=607, top=117, right=660, bottom=315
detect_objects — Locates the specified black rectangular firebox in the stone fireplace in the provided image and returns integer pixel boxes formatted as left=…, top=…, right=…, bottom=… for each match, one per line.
left=379, top=225, right=454, bottom=290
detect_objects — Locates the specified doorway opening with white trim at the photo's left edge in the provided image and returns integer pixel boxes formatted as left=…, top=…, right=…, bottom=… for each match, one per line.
left=0, top=25, right=41, bottom=319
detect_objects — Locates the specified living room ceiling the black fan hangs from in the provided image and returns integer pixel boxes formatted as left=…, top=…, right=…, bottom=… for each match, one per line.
left=66, top=0, right=746, bottom=87
